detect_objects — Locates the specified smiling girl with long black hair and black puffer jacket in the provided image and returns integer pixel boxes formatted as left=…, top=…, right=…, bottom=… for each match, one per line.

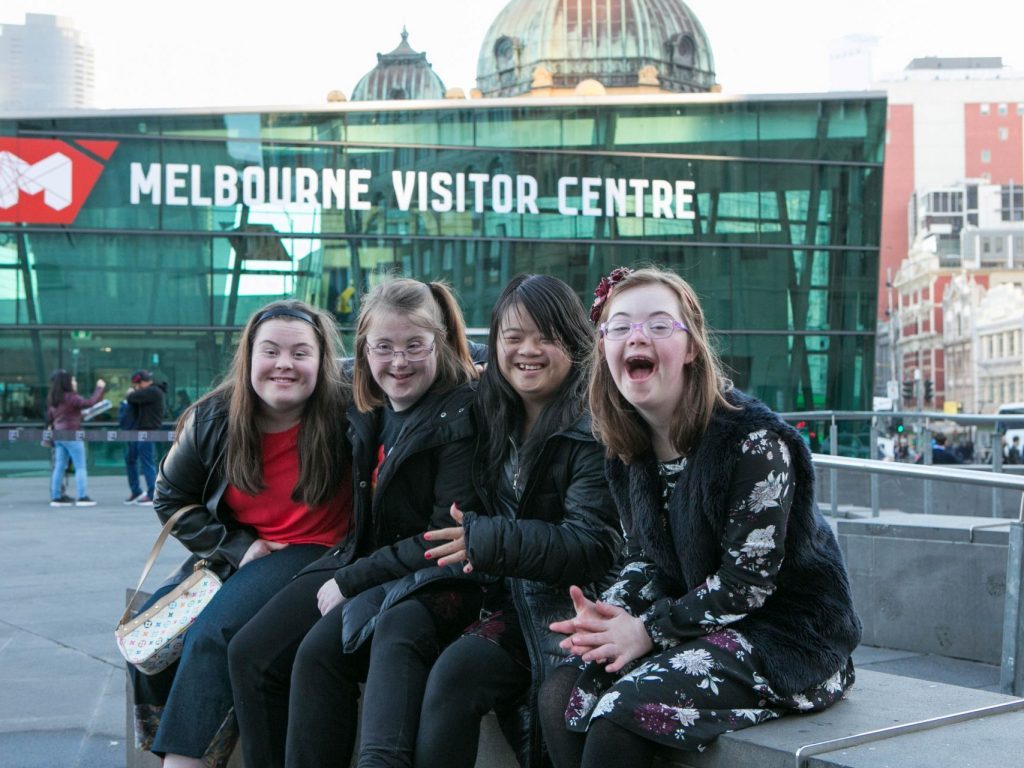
left=403, top=274, right=622, bottom=768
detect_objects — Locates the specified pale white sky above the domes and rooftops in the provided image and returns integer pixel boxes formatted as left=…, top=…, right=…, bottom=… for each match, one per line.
left=0, top=0, right=1024, bottom=110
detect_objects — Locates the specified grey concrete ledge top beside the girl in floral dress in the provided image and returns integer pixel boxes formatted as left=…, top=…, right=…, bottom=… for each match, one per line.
left=660, top=671, right=1024, bottom=768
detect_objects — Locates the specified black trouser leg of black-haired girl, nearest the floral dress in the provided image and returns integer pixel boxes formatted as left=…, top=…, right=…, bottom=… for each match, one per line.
left=416, top=635, right=530, bottom=768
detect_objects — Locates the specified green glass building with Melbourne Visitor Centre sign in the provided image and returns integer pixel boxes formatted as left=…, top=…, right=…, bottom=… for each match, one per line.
left=0, top=93, right=886, bottom=473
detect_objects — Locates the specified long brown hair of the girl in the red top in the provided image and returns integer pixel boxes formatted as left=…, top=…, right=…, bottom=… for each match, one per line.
left=178, top=300, right=351, bottom=507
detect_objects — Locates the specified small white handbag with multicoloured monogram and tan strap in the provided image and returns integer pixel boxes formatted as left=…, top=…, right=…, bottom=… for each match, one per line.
left=114, top=504, right=221, bottom=675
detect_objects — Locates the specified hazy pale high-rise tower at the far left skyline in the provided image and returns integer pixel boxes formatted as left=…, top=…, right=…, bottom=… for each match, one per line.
left=0, top=13, right=94, bottom=113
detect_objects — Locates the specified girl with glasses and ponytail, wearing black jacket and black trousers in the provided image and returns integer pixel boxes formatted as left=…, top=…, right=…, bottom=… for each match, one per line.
left=228, top=280, right=480, bottom=768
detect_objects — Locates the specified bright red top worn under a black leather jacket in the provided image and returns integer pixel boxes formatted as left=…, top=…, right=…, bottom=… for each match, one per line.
left=224, top=424, right=352, bottom=547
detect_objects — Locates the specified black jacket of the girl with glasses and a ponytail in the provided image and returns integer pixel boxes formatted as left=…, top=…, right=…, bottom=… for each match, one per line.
left=302, top=384, right=478, bottom=650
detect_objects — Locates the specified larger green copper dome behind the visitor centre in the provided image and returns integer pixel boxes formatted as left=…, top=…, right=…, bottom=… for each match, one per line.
left=476, top=0, right=715, bottom=96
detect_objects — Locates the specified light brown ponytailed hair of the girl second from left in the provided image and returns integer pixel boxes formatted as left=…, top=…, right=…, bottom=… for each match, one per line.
left=352, top=278, right=476, bottom=412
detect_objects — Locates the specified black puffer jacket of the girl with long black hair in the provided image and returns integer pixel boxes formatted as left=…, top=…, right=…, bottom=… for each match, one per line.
left=463, top=417, right=622, bottom=767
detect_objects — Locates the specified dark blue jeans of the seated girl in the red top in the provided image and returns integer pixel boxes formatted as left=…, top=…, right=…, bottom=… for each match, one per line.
left=128, top=544, right=330, bottom=762
